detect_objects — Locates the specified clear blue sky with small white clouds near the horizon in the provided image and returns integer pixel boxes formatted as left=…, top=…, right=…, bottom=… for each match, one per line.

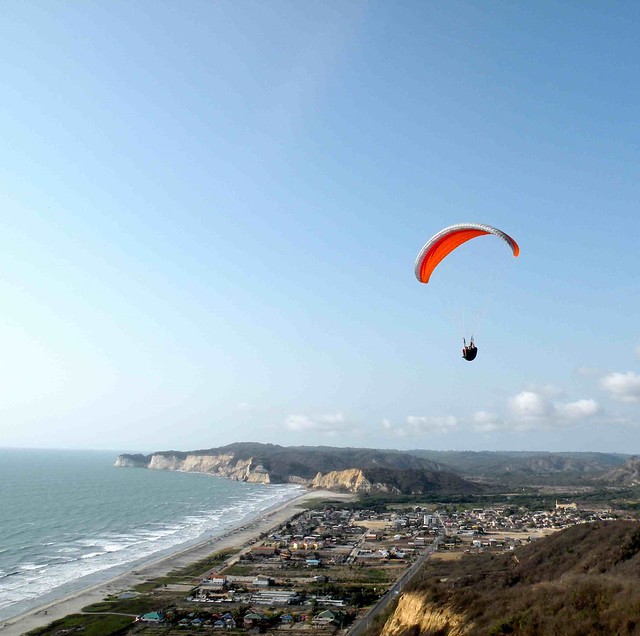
left=0, top=0, right=640, bottom=453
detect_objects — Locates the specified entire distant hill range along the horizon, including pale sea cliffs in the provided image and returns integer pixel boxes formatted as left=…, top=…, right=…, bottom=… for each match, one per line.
left=116, top=442, right=640, bottom=495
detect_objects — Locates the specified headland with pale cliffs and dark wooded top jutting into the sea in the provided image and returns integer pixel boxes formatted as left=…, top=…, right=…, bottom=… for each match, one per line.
left=115, top=443, right=478, bottom=494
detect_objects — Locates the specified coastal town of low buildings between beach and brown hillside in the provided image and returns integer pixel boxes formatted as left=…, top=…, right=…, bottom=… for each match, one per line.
left=75, top=503, right=617, bottom=636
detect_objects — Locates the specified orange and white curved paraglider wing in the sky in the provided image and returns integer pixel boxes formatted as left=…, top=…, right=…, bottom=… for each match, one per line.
left=415, top=223, right=520, bottom=283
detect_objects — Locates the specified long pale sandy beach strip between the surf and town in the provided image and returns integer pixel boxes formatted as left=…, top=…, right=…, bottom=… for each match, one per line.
left=0, top=490, right=353, bottom=636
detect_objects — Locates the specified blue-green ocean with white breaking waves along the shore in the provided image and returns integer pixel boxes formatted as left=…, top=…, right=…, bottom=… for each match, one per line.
left=0, top=449, right=301, bottom=620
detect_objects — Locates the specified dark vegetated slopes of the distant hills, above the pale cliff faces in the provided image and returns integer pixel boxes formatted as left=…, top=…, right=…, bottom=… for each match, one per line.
left=122, top=442, right=640, bottom=494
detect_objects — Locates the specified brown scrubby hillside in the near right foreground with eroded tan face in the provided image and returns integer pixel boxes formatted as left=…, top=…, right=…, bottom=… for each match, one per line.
left=382, top=521, right=640, bottom=636
